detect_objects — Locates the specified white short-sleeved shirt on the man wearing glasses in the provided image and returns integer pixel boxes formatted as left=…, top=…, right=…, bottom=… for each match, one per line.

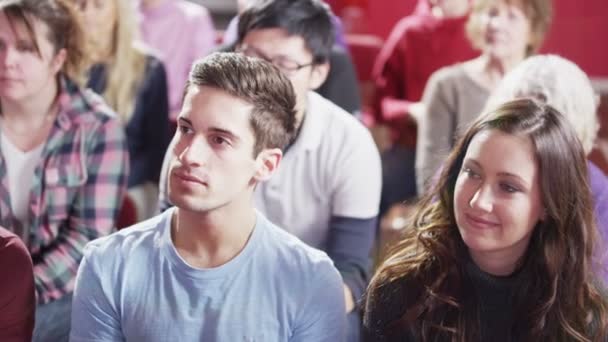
left=255, top=92, right=382, bottom=249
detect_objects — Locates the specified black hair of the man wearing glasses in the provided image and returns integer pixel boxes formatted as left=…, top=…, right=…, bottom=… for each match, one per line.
left=238, top=0, right=334, bottom=64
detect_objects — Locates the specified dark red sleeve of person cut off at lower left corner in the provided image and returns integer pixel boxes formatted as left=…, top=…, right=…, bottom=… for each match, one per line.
left=0, top=227, right=36, bottom=342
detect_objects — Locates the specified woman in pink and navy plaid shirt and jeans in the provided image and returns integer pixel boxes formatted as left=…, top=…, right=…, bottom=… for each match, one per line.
left=0, top=0, right=128, bottom=341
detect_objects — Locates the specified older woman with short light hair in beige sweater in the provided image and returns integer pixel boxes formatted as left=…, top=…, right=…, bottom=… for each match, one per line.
left=416, top=0, right=552, bottom=195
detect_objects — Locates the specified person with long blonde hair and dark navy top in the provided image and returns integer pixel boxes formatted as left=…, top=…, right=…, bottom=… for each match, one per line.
left=73, top=0, right=170, bottom=221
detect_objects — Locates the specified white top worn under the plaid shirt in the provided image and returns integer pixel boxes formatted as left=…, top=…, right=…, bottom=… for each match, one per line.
left=0, top=133, right=44, bottom=227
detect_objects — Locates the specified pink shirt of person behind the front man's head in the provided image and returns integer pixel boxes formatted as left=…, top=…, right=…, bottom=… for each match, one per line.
left=139, top=0, right=216, bottom=120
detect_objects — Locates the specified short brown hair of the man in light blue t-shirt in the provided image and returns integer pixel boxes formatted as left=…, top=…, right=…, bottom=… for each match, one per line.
left=185, top=52, right=296, bottom=156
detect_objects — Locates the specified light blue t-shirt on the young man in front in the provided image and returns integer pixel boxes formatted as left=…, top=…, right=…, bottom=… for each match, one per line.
left=70, top=209, right=346, bottom=342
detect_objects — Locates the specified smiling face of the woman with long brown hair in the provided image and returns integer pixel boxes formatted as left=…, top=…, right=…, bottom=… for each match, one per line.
left=454, top=130, right=543, bottom=274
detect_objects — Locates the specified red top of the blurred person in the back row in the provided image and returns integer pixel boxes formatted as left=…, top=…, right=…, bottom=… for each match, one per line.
left=373, top=4, right=479, bottom=141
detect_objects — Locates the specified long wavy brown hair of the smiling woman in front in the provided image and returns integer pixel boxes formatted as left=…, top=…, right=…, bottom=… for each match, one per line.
left=368, top=99, right=608, bottom=341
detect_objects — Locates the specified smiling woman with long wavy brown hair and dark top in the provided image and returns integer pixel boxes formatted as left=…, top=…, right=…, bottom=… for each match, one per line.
left=364, top=100, right=608, bottom=341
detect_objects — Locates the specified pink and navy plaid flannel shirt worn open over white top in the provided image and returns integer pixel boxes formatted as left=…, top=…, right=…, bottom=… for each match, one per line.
left=0, top=79, right=128, bottom=304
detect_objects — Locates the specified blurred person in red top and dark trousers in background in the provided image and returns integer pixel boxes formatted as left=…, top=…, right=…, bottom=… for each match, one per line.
left=373, top=0, right=479, bottom=214
